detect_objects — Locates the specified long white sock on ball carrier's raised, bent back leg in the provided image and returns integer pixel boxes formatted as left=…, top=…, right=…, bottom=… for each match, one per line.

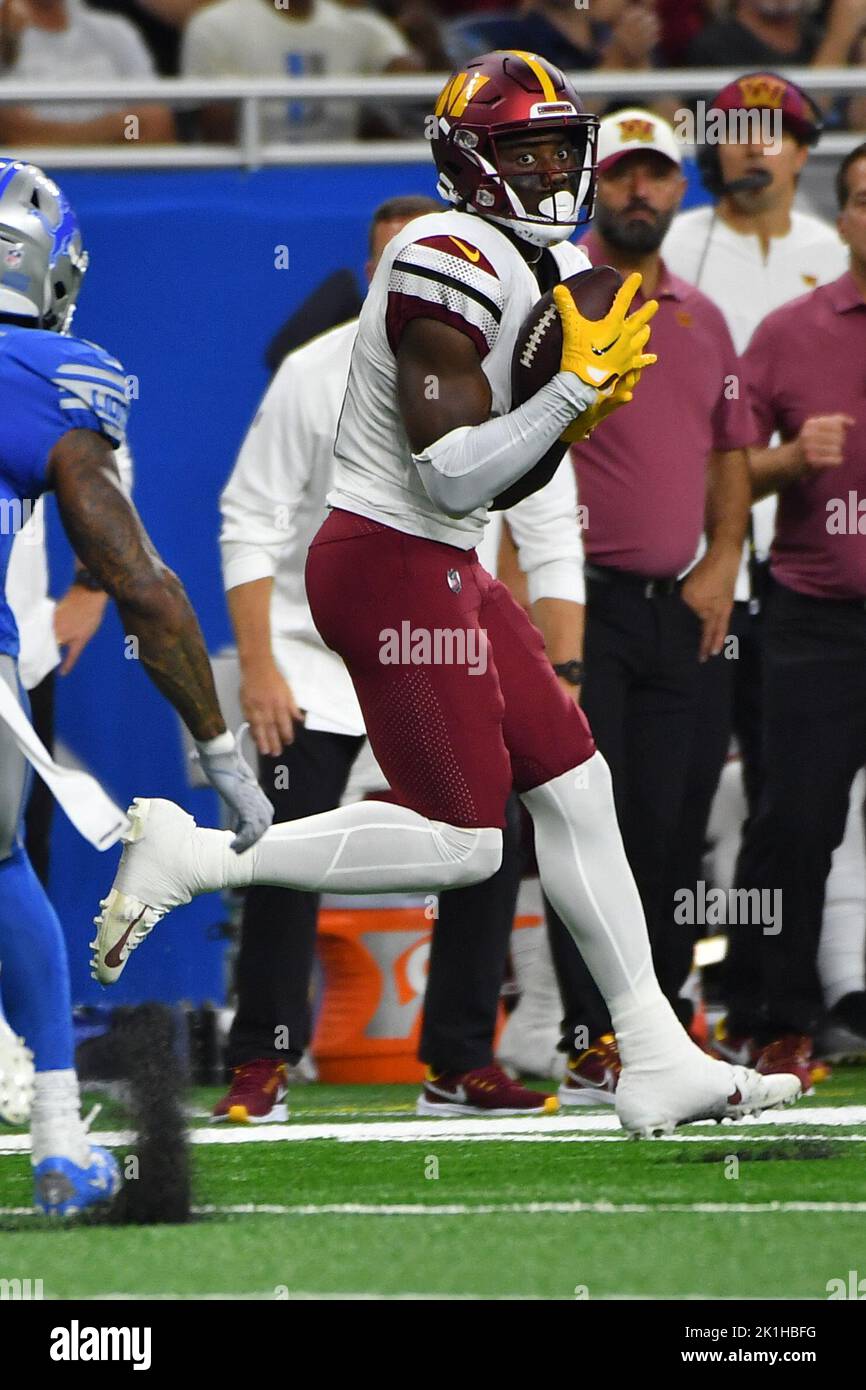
left=192, top=801, right=502, bottom=892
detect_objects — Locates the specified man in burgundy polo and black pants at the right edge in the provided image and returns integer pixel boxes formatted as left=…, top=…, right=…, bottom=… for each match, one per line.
left=728, top=143, right=866, bottom=1045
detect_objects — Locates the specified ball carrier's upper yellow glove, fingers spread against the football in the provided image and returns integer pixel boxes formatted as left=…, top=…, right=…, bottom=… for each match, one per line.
left=553, top=271, right=659, bottom=396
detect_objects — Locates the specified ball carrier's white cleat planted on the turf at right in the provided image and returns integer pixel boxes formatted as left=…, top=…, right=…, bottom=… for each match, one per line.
left=616, top=1048, right=802, bottom=1138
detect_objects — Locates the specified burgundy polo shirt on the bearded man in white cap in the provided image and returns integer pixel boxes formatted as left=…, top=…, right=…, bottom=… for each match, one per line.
left=571, top=232, right=755, bottom=578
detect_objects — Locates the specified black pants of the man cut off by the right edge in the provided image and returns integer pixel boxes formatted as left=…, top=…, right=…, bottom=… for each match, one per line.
left=727, top=585, right=866, bottom=1040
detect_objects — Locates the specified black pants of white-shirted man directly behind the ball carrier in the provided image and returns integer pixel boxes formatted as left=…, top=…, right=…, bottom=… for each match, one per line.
left=227, top=726, right=521, bottom=1072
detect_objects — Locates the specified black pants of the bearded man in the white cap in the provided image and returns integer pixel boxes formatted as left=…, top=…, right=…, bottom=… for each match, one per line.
left=548, top=571, right=701, bottom=1048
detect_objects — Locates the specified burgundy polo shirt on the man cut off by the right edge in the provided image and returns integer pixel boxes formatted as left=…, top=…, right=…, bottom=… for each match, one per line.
left=744, top=271, right=866, bottom=599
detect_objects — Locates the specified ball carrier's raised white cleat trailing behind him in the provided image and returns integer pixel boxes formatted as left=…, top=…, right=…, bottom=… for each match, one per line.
left=90, top=796, right=196, bottom=984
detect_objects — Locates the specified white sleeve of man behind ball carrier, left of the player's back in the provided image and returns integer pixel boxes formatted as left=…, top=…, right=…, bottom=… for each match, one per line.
left=220, top=357, right=314, bottom=592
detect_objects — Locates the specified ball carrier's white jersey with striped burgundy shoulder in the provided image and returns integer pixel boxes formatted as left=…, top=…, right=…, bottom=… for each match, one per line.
left=328, top=211, right=589, bottom=550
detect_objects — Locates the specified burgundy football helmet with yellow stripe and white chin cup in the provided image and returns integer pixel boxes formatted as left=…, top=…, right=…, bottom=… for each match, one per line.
left=432, top=49, right=598, bottom=246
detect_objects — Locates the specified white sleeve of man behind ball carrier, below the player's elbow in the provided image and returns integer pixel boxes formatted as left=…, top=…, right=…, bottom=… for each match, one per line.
left=505, top=455, right=587, bottom=603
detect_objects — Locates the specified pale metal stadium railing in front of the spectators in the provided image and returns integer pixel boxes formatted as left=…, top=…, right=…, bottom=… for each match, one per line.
left=0, top=67, right=866, bottom=170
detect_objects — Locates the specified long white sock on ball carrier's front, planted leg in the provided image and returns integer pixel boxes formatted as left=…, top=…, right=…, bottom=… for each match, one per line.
left=521, top=752, right=696, bottom=1066
